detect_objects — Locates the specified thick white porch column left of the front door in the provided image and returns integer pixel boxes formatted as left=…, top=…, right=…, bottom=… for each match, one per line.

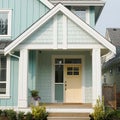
left=18, top=49, right=28, bottom=108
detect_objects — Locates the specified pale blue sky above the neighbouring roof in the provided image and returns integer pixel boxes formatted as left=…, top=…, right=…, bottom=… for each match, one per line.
left=95, top=0, right=120, bottom=36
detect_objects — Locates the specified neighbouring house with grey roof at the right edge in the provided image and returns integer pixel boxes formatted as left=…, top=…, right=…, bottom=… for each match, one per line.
left=102, top=28, right=120, bottom=107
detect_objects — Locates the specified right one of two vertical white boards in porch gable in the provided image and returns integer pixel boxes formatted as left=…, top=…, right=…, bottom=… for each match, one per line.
left=62, top=15, right=67, bottom=49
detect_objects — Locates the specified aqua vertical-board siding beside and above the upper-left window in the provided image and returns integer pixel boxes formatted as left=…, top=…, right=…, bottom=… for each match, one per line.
left=0, top=0, right=48, bottom=39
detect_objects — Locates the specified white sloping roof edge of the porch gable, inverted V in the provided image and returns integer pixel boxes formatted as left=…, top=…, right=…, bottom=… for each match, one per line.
left=4, top=4, right=116, bottom=54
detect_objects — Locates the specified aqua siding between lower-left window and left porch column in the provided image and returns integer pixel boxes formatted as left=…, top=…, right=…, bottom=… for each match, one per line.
left=0, top=57, right=19, bottom=106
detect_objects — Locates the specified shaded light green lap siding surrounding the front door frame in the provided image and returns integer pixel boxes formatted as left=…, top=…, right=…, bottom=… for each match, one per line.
left=36, top=51, right=92, bottom=103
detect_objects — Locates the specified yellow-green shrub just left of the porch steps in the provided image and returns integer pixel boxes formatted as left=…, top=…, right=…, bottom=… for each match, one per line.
left=32, top=106, right=48, bottom=120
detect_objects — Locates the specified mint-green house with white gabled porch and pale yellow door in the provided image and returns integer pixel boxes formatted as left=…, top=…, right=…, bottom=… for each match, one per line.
left=0, top=0, right=116, bottom=112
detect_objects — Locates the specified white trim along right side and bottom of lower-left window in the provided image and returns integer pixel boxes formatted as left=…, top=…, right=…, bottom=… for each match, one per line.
left=0, top=56, right=10, bottom=98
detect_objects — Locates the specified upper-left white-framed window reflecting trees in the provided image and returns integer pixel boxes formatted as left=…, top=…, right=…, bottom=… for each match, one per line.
left=0, top=10, right=11, bottom=37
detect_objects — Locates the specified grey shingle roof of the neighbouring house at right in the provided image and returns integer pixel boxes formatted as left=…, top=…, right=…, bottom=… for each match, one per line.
left=107, top=28, right=120, bottom=46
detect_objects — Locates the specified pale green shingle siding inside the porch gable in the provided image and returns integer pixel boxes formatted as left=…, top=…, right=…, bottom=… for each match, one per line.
left=21, top=14, right=99, bottom=45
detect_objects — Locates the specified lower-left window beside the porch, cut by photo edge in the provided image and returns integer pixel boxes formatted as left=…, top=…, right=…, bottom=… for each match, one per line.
left=0, top=54, right=9, bottom=98
